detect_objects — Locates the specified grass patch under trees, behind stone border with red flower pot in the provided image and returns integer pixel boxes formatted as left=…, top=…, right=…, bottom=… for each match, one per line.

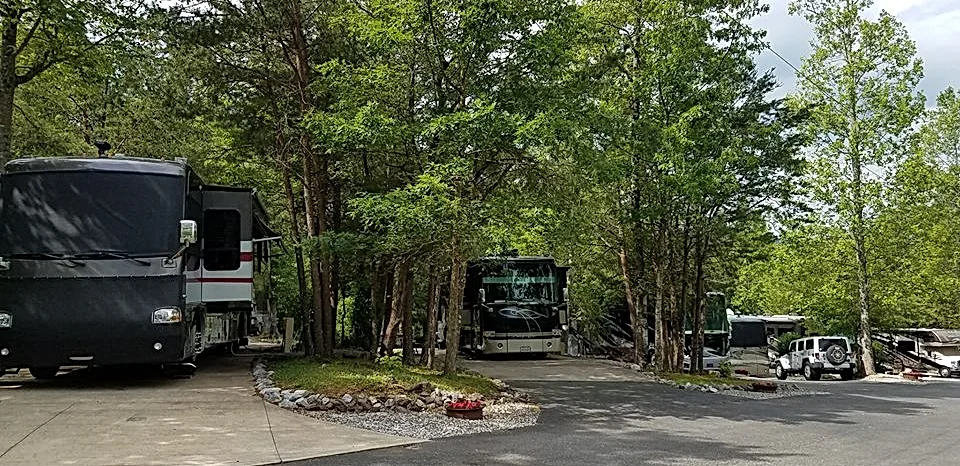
left=269, top=358, right=499, bottom=396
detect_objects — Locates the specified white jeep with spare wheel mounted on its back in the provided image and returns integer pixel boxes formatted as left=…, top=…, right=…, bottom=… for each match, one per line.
left=774, top=336, right=857, bottom=380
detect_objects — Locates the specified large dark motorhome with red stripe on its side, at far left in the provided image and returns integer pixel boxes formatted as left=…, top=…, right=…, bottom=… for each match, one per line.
left=0, top=158, right=276, bottom=378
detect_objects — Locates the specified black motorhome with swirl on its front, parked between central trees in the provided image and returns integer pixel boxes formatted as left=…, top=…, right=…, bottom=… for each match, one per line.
left=460, top=257, right=569, bottom=355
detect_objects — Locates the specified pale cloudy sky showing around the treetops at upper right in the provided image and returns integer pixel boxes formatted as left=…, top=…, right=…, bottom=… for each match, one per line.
left=753, top=0, right=960, bottom=105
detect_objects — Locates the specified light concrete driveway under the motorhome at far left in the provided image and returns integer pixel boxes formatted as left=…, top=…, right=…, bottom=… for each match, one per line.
left=0, top=357, right=417, bottom=466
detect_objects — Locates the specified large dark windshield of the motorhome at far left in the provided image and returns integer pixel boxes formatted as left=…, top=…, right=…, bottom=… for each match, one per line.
left=0, top=171, right=184, bottom=257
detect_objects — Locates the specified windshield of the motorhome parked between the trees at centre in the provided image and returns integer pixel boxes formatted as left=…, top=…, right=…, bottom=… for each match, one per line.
left=483, top=262, right=557, bottom=302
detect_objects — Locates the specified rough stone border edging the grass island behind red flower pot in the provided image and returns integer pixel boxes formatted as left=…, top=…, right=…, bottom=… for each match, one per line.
left=253, top=360, right=531, bottom=412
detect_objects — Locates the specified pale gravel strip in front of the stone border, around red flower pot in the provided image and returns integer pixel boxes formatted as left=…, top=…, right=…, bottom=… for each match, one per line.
left=307, top=403, right=540, bottom=439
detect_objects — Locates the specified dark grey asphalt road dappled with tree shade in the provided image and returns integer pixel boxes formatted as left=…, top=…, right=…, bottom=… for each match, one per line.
left=296, top=361, right=960, bottom=466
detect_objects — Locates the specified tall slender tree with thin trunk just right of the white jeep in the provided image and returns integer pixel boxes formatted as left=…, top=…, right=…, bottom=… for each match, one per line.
left=790, top=0, right=923, bottom=374
